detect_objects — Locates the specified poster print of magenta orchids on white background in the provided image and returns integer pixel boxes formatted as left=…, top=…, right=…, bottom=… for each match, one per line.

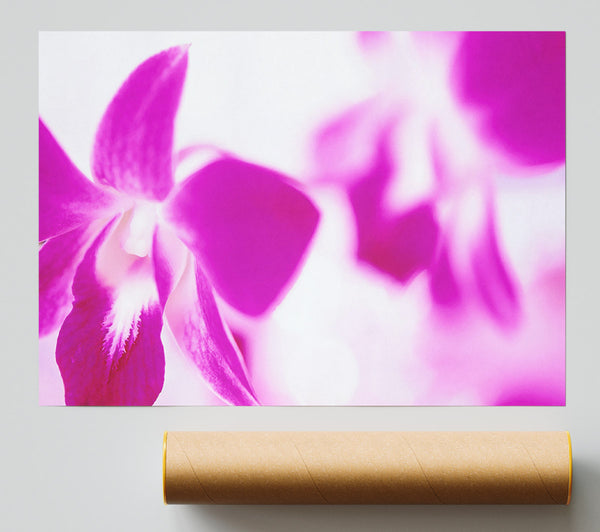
left=39, top=32, right=565, bottom=405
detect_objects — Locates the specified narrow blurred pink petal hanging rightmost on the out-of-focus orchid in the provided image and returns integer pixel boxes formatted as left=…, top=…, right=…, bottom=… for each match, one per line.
left=471, top=218, right=520, bottom=326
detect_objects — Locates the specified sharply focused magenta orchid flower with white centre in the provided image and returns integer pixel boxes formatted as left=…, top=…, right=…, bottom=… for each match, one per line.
left=39, top=46, right=319, bottom=405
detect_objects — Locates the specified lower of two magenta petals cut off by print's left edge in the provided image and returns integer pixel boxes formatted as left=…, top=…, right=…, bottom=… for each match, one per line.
left=39, top=225, right=97, bottom=336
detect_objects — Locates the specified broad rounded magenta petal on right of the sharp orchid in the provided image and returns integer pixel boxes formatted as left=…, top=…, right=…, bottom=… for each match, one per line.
left=165, top=159, right=319, bottom=315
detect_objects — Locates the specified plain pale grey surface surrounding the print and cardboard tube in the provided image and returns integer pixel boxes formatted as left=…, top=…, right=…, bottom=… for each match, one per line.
left=0, top=0, right=600, bottom=532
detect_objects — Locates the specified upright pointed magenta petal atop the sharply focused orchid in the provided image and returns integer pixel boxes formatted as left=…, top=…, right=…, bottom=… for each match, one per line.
left=93, top=46, right=187, bottom=200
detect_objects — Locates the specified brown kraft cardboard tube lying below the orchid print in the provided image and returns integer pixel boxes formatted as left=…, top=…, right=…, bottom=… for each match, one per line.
left=163, top=432, right=572, bottom=504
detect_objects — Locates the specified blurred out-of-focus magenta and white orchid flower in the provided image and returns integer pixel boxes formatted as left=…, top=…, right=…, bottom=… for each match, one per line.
left=315, top=32, right=565, bottom=326
